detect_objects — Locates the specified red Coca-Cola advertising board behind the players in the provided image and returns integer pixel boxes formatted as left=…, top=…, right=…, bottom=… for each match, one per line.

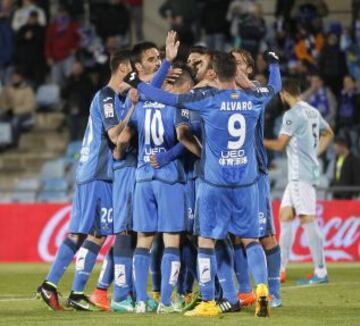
left=0, top=201, right=360, bottom=262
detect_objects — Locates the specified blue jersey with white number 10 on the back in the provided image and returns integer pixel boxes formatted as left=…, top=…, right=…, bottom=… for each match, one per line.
left=129, top=101, right=186, bottom=184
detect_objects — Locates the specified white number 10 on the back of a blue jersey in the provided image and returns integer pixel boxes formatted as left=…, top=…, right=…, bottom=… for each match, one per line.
left=145, top=109, right=164, bottom=146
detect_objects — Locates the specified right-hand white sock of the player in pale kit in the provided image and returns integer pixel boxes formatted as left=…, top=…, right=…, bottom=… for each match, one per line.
left=303, top=221, right=327, bottom=277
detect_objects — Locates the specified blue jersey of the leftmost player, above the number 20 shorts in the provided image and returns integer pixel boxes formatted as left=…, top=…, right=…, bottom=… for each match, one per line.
left=76, top=86, right=119, bottom=184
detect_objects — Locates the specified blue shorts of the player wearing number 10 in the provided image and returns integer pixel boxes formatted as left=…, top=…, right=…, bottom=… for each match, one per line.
left=133, top=180, right=185, bottom=232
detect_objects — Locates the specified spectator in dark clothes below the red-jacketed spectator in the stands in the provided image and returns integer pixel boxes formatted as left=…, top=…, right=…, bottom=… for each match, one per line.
left=62, top=61, right=94, bottom=141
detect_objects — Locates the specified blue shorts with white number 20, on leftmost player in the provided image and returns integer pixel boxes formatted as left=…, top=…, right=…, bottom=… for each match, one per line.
left=69, top=180, right=113, bottom=235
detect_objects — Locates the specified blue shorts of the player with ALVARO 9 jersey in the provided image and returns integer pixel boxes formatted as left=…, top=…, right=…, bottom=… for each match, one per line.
left=197, top=181, right=259, bottom=240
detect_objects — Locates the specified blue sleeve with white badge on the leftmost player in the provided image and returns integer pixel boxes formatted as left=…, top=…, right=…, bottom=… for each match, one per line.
left=98, top=88, right=119, bottom=131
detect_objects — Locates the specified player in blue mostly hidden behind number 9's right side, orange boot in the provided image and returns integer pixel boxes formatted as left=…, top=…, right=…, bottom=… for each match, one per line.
left=230, top=49, right=281, bottom=308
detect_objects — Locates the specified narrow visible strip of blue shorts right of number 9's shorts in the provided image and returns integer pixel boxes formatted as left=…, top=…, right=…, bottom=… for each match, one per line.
left=258, top=174, right=275, bottom=238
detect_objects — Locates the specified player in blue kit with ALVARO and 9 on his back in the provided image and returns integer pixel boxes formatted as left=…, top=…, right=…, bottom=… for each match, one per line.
left=125, top=53, right=280, bottom=317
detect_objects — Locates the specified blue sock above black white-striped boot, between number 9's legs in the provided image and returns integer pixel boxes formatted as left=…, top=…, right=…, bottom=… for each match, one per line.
left=215, top=240, right=238, bottom=304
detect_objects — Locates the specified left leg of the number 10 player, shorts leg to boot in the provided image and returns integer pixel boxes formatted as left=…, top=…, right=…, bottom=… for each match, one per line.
left=133, top=181, right=158, bottom=313
